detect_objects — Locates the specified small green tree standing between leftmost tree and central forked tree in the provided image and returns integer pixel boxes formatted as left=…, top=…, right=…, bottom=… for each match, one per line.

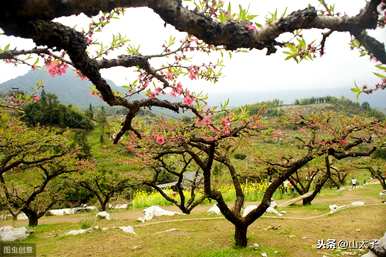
left=71, top=118, right=148, bottom=211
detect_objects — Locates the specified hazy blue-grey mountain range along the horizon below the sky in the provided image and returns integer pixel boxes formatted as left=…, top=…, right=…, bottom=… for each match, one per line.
left=0, top=70, right=386, bottom=112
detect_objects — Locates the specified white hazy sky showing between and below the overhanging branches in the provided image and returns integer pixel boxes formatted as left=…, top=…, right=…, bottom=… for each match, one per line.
left=0, top=0, right=386, bottom=92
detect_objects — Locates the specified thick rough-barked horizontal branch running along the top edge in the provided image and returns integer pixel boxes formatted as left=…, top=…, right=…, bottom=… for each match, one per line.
left=0, top=0, right=386, bottom=60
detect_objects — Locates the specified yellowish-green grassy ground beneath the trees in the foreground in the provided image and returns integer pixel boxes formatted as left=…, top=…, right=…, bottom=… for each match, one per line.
left=0, top=182, right=386, bottom=257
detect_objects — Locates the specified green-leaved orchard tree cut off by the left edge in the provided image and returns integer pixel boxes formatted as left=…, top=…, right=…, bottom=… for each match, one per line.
left=0, top=112, right=86, bottom=226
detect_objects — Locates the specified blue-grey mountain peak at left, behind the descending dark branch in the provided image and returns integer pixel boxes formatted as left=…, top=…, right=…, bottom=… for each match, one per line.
left=0, top=69, right=130, bottom=108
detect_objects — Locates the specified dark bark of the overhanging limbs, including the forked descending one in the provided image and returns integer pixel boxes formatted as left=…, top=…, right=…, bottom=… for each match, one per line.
left=0, top=0, right=386, bottom=140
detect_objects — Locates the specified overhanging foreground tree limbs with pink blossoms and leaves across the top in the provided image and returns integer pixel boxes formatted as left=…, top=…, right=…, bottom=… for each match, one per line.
left=0, top=0, right=386, bottom=143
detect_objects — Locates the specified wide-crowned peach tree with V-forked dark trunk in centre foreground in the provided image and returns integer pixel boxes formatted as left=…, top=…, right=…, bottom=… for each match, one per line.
left=128, top=109, right=385, bottom=247
